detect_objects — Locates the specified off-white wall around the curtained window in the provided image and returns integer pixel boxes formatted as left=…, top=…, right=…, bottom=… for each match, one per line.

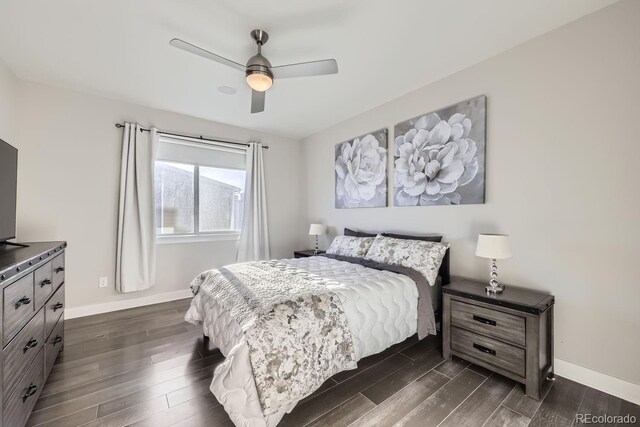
left=15, top=81, right=304, bottom=308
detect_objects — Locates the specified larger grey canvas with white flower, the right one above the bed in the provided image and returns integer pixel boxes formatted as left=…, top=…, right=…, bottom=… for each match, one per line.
left=394, top=96, right=486, bottom=206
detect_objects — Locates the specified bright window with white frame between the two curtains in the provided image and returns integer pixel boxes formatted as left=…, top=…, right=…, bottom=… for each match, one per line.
left=154, top=140, right=246, bottom=242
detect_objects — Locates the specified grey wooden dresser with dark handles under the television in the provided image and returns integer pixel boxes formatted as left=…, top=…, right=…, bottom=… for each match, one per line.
left=0, top=242, right=67, bottom=427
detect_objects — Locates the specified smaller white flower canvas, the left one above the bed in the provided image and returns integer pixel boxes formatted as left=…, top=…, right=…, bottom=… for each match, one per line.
left=335, top=129, right=388, bottom=209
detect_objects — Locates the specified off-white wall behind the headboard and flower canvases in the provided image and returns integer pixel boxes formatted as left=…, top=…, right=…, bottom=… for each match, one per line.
left=300, top=0, right=640, bottom=384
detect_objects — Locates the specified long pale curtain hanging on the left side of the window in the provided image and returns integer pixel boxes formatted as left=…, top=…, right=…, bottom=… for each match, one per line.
left=116, top=123, right=158, bottom=292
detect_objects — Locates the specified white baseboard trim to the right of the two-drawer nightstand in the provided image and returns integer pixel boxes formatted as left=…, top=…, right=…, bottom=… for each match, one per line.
left=554, top=358, right=640, bottom=405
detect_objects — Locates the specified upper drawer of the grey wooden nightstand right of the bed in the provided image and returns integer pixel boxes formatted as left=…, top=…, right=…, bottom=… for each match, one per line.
left=451, top=301, right=526, bottom=346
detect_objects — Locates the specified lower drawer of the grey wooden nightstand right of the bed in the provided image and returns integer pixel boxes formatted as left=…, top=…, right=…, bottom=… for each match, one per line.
left=451, top=326, right=525, bottom=377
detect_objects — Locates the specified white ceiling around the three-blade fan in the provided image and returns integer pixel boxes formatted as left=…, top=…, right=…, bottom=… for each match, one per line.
left=0, top=0, right=616, bottom=138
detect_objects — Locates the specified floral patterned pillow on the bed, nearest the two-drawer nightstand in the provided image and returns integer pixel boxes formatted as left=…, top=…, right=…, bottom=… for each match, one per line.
left=365, top=235, right=449, bottom=286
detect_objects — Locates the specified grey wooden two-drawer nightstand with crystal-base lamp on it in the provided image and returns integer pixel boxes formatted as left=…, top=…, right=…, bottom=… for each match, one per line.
left=442, top=279, right=554, bottom=400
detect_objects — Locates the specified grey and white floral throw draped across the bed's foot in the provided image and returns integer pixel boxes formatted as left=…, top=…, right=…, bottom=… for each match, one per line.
left=191, top=261, right=356, bottom=416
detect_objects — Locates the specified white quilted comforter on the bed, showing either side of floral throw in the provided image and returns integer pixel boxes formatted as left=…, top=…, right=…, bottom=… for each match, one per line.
left=185, top=257, right=418, bottom=427
